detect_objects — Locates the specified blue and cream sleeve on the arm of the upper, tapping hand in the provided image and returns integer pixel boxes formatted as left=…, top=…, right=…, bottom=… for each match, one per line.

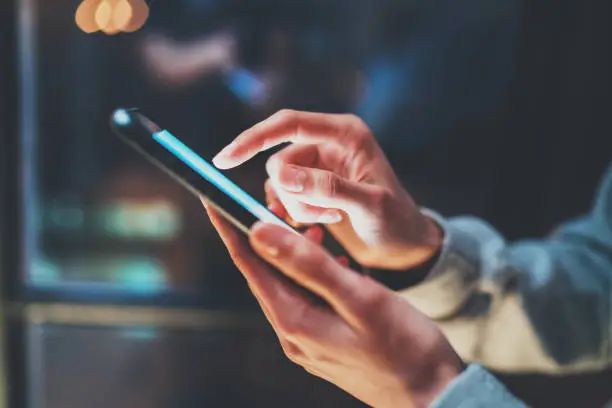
left=401, top=167, right=612, bottom=373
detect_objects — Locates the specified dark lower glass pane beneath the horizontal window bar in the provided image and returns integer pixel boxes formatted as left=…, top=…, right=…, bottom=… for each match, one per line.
left=29, top=325, right=362, bottom=408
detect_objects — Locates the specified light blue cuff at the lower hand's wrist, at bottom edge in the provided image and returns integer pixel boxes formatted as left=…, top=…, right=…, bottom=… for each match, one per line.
left=430, top=364, right=527, bottom=408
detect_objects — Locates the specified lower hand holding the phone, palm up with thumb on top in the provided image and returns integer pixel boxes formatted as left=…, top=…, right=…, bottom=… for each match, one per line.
left=203, top=204, right=462, bottom=408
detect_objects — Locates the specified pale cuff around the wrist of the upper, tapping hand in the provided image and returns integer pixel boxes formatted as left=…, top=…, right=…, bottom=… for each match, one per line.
left=399, top=210, right=479, bottom=319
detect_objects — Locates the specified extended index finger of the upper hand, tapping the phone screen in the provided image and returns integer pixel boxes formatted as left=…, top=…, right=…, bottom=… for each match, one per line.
left=213, top=110, right=356, bottom=169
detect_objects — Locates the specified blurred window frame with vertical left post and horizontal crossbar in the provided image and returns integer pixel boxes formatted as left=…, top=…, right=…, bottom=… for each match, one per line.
left=0, top=0, right=266, bottom=408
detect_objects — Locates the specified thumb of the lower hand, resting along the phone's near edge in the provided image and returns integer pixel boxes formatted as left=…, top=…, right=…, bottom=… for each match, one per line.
left=250, top=223, right=381, bottom=324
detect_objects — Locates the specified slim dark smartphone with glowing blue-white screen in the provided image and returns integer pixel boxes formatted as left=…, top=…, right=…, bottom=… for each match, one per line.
left=111, top=108, right=361, bottom=271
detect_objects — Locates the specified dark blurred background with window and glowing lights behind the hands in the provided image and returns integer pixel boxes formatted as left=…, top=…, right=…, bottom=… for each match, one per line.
left=0, top=0, right=612, bottom=408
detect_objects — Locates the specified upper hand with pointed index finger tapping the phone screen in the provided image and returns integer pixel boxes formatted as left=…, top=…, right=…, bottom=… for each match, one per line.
left=213, top=111, right=442, bottom=270
